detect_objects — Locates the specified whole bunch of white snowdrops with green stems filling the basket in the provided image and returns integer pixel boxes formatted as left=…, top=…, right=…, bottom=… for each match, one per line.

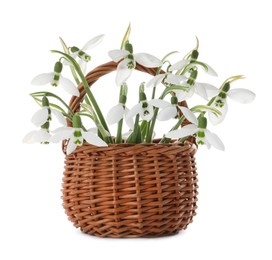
left=24, top=26, right=255, bottom=154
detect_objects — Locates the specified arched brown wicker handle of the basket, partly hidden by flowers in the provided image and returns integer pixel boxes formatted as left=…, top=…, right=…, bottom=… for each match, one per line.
left=67, top=61, right=190, bottom=126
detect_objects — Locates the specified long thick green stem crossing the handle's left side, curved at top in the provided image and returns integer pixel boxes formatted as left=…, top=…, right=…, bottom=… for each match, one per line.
left=52, top=50, right=113, bottom=143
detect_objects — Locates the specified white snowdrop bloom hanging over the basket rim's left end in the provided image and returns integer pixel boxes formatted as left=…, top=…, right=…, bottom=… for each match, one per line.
left=49, top=115, right=108, bottom=155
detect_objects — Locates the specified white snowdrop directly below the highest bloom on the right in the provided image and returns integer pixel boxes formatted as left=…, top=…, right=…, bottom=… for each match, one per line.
left=174, top=69, right=219, bottom=101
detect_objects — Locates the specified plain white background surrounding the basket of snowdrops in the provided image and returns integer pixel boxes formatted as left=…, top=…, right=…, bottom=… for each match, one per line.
left=0, top=0, right=272, bottom=260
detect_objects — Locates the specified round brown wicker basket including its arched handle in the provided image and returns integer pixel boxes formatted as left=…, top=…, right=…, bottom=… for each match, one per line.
left=62, top=62, right=197, bottom=237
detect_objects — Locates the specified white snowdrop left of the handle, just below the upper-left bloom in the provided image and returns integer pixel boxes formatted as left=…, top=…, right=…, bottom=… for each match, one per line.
left=31, top=61, right=79, bottom=97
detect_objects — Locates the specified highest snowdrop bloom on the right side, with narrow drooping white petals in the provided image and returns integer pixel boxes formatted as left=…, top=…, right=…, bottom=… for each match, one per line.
left=169, top=50, right=217, bottom=77
